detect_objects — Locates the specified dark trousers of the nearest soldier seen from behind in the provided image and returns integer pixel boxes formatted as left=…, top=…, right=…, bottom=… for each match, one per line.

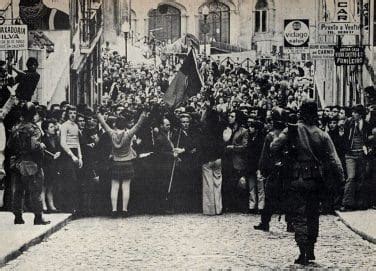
left=290, top=188, right=320, bottom=246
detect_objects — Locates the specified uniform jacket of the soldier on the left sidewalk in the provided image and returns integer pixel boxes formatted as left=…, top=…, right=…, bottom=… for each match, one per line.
left=8, top=122, right=43, bottom=176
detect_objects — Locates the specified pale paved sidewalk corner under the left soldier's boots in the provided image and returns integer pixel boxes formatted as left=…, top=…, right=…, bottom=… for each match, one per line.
left=0, top=212, right=71, bottom=267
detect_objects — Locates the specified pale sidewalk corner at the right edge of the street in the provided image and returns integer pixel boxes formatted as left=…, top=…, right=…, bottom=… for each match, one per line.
left=337, top=209, right=376, bottom=244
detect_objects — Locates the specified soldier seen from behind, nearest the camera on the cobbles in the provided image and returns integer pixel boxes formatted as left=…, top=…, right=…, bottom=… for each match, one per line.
left=270, top=100, right=344, bottom=265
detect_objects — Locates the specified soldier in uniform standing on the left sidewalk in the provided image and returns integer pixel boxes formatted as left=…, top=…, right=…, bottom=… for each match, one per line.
left=8, top=102, right=50, bottom=225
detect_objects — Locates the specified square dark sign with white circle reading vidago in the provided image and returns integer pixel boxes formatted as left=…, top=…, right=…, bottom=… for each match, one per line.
left=284, top=19, right=309, bottom=48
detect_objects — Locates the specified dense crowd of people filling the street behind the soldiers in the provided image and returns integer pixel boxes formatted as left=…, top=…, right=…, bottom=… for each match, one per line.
left=0, top=50, right=376, bottom=236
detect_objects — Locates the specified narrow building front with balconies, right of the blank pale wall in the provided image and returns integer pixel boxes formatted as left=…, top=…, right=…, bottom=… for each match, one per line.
left=68, top=0, right=103, bottom=106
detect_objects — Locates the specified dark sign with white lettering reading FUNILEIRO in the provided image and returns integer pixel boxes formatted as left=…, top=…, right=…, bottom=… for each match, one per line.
left=334, top=46, right=364, bottom=66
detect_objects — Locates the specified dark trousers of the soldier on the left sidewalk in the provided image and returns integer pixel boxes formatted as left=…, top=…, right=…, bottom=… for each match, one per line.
left=13, top=169, right=43, bottom=215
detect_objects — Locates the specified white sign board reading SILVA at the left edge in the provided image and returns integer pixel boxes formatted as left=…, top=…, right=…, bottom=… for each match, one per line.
left=0, top=25, right=28, bottom=51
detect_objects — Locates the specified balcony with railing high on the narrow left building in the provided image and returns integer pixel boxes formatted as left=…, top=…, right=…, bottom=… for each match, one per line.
left=80, top=2, right=103, bottom=53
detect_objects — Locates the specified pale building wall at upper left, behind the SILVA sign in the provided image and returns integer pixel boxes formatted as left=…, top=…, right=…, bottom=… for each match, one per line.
left=0, top=0, right=70, bottom=106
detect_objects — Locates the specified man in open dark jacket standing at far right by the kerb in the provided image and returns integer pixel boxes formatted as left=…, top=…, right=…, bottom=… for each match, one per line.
left=341, top=105, right=371, bottom=211
